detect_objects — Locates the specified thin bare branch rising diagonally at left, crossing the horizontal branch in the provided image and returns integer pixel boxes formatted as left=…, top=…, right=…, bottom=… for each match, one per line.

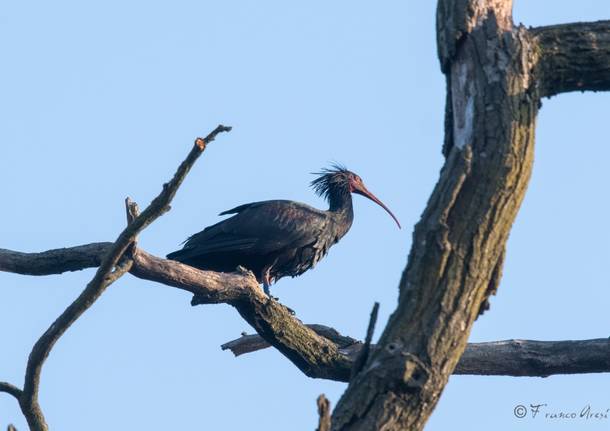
left=2, top=125, right=231, bottom=431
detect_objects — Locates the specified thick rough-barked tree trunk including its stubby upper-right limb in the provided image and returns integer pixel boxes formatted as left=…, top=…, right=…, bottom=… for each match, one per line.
left=332, top=0, right=610, bottom=430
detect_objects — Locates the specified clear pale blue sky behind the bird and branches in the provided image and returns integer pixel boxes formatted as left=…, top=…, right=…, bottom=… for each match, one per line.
left=0, top=0, right=610, bottom=431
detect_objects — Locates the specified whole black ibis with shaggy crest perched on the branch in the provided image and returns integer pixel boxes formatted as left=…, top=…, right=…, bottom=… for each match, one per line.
left=167, top=165, right=400, bottom=295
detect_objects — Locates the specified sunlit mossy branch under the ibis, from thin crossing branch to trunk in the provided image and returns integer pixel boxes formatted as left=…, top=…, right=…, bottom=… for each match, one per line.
left=131, top=249, right=351, bottom=380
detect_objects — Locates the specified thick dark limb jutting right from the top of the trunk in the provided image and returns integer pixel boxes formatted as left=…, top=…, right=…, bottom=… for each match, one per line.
left=531, top=21, right=610, bottom=97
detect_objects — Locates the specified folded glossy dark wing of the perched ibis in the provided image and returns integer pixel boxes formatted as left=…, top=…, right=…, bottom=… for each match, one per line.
left=168, top=200, right=327, bottom=260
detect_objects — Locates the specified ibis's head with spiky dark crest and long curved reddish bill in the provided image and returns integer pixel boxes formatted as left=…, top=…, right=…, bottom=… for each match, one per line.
left=311, top=164, right=400, bottom=228
